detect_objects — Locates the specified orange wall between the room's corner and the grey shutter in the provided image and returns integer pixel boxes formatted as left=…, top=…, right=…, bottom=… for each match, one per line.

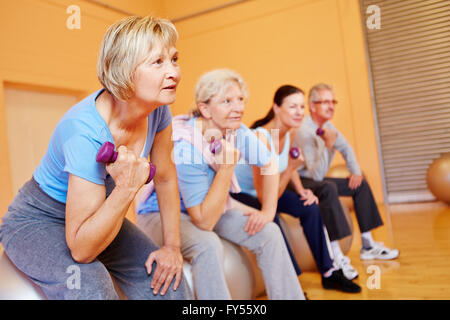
left=173, top=0, right=383, bottom=202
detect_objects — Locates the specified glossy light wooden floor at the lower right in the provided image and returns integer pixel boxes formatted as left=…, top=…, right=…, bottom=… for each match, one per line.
left=299, top=203, right=450, bottom=300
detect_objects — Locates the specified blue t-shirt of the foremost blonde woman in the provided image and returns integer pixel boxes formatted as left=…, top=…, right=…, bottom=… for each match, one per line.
left=33, top=89, right=172, bottom=203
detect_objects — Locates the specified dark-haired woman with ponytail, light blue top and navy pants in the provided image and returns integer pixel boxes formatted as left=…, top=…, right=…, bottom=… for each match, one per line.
left=232, top=85, right=361, bottom=293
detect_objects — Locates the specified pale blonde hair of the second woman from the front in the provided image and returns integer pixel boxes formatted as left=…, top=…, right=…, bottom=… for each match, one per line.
left=191, top=69, right=248, bottom=116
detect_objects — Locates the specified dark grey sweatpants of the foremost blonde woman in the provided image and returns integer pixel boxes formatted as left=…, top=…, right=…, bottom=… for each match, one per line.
left=0, top=179, right=192, bottom=300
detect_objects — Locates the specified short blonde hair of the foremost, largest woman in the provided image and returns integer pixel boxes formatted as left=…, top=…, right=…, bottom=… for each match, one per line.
left=97, top=16, right=178, bottom=101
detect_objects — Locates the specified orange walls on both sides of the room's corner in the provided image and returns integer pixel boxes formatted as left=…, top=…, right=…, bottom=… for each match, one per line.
left=0, top=0, right=383, bottom=220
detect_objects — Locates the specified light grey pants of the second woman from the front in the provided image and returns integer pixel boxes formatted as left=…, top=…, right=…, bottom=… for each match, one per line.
left=137, top=209, right=305, bottom=300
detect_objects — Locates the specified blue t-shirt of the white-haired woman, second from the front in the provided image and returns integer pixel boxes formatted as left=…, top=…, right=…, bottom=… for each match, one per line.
left=137, top=117, right=271, bottom=214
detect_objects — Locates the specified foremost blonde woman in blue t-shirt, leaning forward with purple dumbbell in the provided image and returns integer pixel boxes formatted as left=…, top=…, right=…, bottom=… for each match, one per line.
left=0, top=17, right=190, bottom=299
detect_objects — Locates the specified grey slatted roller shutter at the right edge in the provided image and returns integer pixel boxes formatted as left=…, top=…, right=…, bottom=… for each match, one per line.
left=360, top=0, right=450, bottom=203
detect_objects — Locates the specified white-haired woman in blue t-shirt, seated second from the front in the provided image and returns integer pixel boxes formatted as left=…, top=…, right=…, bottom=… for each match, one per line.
left=137, top=69, right=304, bottom=299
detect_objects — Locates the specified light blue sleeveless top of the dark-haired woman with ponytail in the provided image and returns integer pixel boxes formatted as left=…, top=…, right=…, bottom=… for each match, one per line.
left=234, top=127, right=290, bottom=197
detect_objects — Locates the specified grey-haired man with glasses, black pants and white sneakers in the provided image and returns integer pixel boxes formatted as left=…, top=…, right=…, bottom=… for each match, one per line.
left=294, top=83, right=399, bottom=280
